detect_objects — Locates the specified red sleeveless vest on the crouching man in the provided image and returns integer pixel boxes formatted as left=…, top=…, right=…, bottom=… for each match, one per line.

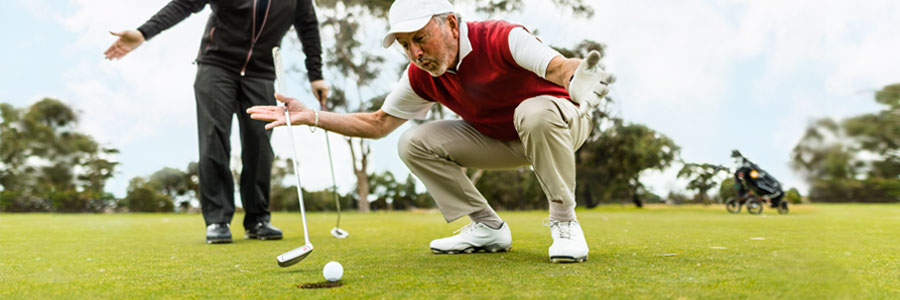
left=408, top=20, right=570, bottom=141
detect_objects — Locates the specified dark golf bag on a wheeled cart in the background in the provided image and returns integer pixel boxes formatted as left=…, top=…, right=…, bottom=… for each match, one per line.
left=725, top=150, right=788, bottom=215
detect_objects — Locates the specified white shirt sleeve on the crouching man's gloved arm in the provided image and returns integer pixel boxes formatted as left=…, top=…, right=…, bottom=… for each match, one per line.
left=509, top=27, right=561, bottom=79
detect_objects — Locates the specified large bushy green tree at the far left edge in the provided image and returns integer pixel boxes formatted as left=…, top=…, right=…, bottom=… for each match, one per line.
left=0, top=98, right=118, bottom=212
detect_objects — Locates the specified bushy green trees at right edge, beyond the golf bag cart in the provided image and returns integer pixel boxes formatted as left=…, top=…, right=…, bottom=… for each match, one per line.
left=791, top=83, right=900, bottom=202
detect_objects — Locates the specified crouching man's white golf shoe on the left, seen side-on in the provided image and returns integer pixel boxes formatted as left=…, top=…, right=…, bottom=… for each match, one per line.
left=431, top=222, right=512, bottom=254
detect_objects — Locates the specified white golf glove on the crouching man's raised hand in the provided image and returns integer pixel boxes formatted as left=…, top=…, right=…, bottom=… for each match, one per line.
left=569, top=50, right=616, bottom=115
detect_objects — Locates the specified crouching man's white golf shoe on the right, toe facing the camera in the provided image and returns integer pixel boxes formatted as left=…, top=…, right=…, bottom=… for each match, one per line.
left=544, top=219, right=588, bottom=263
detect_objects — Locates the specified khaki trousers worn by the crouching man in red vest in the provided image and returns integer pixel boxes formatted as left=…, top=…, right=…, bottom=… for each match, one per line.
left=398, top=96, right=592, bottom=222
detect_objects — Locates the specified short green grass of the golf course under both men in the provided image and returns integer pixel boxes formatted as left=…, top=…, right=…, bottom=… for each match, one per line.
left=0, top=205, right=900, bottom=299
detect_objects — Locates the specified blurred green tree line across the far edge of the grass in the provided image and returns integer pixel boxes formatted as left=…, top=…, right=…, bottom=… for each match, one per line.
left=0, top=84, right=900, bottom=212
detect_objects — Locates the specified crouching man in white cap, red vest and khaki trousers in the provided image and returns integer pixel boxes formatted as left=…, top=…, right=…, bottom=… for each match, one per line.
left=247, top=0, right=615, bottom=262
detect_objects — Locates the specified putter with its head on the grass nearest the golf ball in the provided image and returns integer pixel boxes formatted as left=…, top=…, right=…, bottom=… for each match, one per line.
left=272, top=47, right=313, bottom=267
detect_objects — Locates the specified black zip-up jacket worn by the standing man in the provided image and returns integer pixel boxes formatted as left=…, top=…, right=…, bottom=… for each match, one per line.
left=138, top=0, right=322, bottom=81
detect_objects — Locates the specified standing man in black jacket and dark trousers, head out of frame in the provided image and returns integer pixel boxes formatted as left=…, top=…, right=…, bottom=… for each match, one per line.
left=104, top=0, right=328, bottom=243
